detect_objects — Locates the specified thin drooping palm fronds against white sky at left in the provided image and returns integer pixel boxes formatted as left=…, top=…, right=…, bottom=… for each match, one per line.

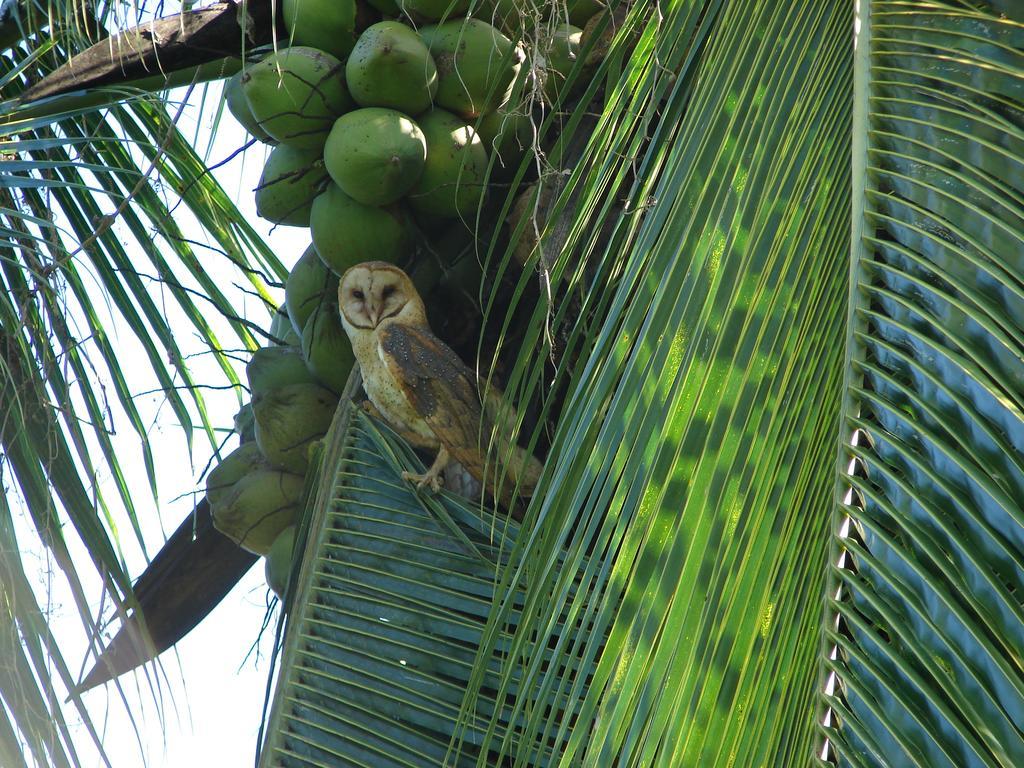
left=0, top=9, right=286, bottom=765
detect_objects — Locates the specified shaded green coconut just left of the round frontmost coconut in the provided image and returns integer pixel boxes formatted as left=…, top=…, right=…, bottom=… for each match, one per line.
left=256, top=144, right=328, bottom=226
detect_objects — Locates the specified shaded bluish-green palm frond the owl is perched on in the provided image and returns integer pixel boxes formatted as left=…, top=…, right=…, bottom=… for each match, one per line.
left=262, top=404, right=593, bottom=767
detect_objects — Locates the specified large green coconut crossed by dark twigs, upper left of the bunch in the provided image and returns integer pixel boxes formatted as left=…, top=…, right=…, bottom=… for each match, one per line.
left=242, top=45, right=352, bottom=150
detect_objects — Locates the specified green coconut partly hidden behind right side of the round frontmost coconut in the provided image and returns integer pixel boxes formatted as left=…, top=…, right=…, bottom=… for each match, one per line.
left=407, top=110, right=487, bottom=218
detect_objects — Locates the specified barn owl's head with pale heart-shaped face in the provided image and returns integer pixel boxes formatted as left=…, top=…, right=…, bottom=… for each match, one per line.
left=338, top=261, right=426, bottom=330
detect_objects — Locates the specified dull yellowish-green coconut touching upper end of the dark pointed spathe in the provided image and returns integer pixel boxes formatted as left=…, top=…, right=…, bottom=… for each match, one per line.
left=211, top=469, right=305, bottom=555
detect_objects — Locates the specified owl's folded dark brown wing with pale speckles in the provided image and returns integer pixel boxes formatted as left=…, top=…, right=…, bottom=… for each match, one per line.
left=378, top=323, right=494, bottom=479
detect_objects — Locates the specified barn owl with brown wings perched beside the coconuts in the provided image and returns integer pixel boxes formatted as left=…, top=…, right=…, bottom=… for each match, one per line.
left=338, top=261, right=542, bottom=509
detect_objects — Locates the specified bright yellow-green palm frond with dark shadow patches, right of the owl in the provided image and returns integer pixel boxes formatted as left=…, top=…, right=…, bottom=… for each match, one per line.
left=458, top=2, right=852, bottom=766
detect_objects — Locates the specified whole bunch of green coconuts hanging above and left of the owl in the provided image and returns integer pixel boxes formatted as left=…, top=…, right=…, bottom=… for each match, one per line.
left=207, top=0, right=604, bottom=595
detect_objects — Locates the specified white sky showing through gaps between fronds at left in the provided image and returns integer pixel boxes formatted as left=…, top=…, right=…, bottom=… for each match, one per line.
left=12, top=84, right=309, bottom=768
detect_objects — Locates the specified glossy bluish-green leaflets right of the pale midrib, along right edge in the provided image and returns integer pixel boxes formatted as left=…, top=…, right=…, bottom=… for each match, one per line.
left=827, top=2, right=1024, bottom=768
